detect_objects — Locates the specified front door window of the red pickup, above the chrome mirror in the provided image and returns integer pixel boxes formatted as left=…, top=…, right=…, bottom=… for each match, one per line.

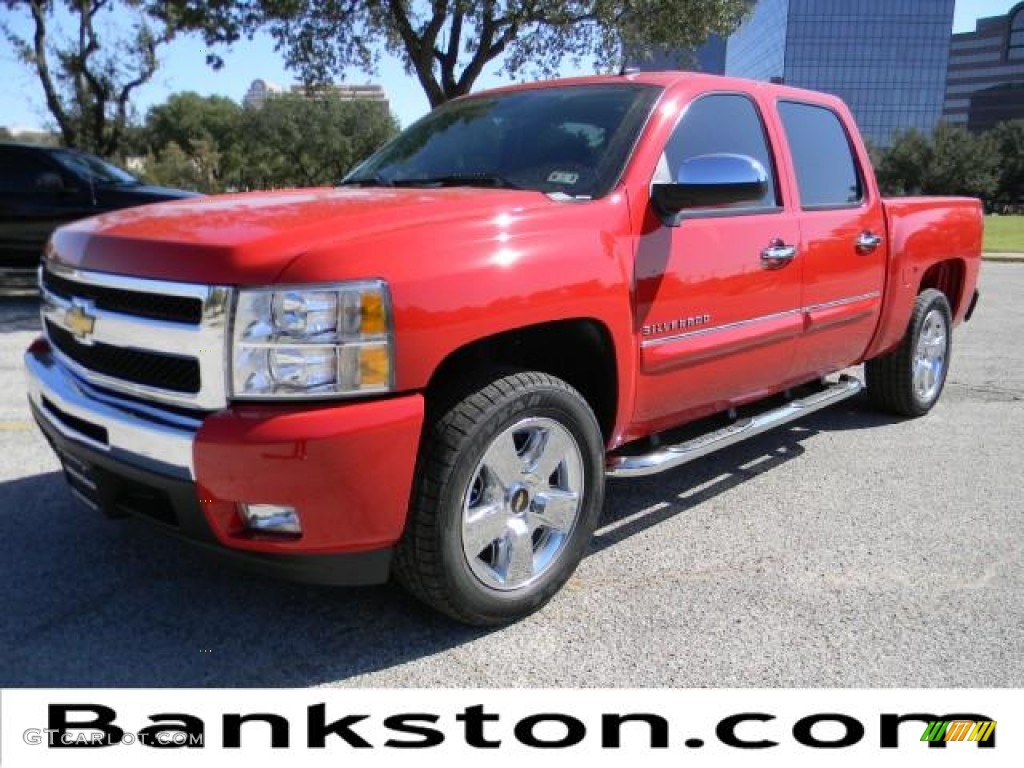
left=655, top=93, right=778, bottom=208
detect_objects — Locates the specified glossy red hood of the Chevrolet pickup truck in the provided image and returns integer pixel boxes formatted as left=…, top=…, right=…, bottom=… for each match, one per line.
left=48, top=187, right=556, bottom=285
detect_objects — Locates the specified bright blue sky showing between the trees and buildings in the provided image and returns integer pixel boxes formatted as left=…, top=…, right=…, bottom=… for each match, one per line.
left=0, top=0, right=1019, bottom=131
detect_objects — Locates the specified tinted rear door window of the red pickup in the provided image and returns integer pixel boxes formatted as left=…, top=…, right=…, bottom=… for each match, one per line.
left=778, top=101, right=864, bottom=209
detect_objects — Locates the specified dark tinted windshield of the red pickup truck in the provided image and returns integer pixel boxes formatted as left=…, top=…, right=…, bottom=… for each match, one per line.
left=341, top=83, right=660, bottom=199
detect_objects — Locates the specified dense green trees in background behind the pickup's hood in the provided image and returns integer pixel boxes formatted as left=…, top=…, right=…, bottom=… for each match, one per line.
left=132, top=93, right=397, bottom=193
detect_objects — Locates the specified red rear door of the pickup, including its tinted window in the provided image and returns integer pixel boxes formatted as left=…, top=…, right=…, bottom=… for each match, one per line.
left=778, top=100, right=888, bottom=379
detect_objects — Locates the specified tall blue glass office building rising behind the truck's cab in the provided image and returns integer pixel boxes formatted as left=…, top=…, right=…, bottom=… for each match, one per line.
left=725, top=0, right=954, bottom=146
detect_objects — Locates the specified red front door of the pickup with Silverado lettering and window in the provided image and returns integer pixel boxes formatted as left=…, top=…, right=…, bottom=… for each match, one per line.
left=635, top=92, right=802, bottom=430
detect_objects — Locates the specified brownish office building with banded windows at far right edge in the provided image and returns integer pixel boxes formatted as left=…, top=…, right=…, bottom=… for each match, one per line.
left=943, top=2, right=1024, bottom=133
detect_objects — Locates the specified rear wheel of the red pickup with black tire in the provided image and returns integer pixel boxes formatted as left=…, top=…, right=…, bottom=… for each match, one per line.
left=864, top=288, right=953, bottom=417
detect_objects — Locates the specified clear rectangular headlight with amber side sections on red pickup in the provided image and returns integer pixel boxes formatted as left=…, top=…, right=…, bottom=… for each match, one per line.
left=231, top=281, right=392, bottom=398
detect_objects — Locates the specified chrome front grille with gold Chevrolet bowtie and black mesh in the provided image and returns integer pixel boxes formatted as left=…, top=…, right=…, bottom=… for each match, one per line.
left=40, top=263, right=231, bottom=411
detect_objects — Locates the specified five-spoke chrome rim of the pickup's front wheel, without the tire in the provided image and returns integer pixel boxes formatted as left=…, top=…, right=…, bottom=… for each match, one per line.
left=462, top=417, right=584, bottom=591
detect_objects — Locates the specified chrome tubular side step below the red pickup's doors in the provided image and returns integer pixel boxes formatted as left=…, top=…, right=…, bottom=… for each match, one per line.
left=606, top=374, right=864, bottom=477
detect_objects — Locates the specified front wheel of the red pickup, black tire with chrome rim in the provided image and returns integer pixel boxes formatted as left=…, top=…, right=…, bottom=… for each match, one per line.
left=393, top=372, right=604, bottom=626
